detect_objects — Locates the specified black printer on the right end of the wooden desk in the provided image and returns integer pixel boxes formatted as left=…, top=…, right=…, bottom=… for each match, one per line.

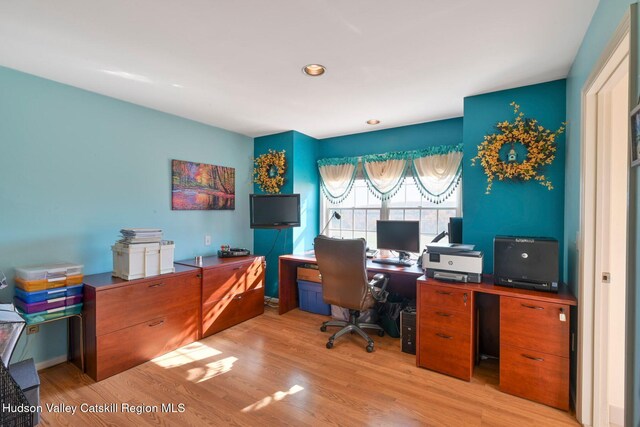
left=493, top=236, right=560, bottom=292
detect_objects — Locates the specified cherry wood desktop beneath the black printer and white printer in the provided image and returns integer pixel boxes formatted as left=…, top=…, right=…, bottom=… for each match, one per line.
left=418, top=275, right=578, bottom=306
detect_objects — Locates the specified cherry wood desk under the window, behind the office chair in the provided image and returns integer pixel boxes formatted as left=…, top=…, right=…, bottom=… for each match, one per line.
left=278, top=253, right=423, bottom=314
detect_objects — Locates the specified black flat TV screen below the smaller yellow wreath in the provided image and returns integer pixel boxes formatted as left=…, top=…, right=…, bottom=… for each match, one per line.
left=249, top=194, right=300, bottom=228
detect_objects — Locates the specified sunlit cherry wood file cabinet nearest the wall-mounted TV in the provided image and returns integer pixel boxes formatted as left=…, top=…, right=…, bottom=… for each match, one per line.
left=178, top=256, right=265, bottom=338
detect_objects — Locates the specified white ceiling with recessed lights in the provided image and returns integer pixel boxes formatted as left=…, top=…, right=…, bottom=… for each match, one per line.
left=0, top=0, right=598, bottom=138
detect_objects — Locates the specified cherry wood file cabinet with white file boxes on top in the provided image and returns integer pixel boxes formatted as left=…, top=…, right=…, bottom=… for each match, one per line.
left=83, top=265, right=201, bottom=381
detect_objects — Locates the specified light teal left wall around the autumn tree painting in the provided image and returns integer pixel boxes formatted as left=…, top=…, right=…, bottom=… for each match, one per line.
left=0, top=68, right=253, bottom=362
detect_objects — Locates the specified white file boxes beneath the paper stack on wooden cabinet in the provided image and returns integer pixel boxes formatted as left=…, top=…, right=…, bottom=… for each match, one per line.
left=111, top=243, right=175, bottom=280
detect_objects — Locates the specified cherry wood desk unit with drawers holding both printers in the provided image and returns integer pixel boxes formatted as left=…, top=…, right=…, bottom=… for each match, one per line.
left=416, top=276, right=577, bottom=410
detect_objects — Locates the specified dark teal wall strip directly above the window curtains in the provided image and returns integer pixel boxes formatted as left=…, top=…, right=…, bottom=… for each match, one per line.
left=318, top=117, right=462, bottom=158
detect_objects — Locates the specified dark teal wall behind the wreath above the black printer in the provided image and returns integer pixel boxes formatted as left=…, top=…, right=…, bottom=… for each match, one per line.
left=462, top=80, right=566, bottom=273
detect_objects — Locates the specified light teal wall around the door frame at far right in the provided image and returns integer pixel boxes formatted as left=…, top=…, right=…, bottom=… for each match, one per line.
left=564, top=0, right=640, bottom=426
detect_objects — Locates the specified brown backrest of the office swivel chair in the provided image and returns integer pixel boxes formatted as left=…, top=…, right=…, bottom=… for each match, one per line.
left=314, top=236, right=369, bottom=310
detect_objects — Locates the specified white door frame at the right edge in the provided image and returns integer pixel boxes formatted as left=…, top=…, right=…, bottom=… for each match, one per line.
left=576, top=12, right=631, bottom=425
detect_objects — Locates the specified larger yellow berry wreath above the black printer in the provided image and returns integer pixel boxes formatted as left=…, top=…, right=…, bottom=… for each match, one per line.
left=471, top=102, right=565, bottom=194
